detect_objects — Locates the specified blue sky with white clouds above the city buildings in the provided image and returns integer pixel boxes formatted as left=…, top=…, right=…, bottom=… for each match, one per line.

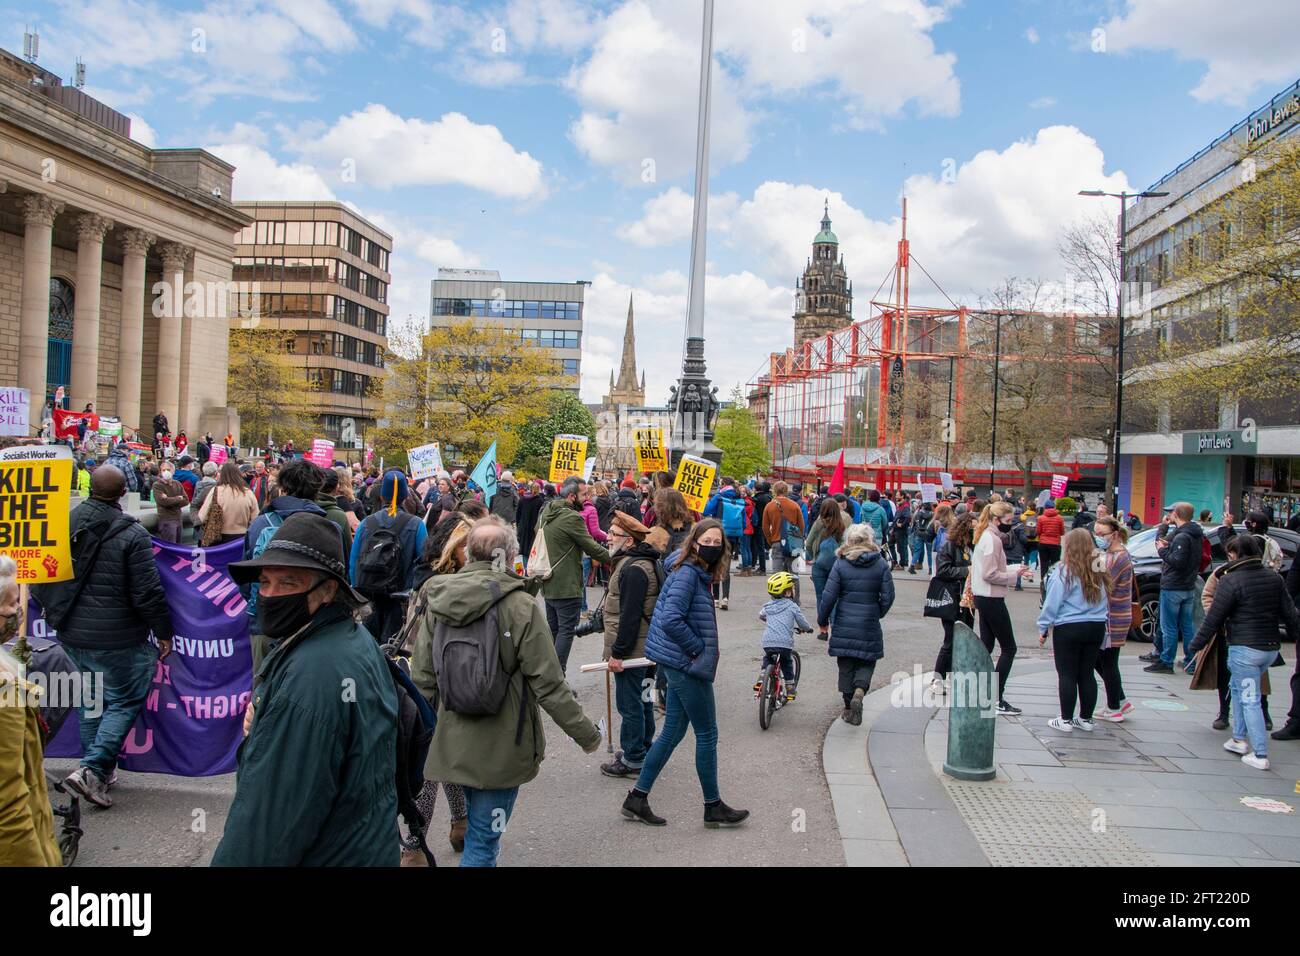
left=10, top=0, right=1300, bottom=401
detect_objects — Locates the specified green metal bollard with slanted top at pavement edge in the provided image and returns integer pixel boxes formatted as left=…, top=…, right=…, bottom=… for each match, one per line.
left=944, top=620, right=997, bottom=780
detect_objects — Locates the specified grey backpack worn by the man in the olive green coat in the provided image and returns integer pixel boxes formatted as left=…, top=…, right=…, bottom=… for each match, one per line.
left=433, top=580, right=528, bottom=730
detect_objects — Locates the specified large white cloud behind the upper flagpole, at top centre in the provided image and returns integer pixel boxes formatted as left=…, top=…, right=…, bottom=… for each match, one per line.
left=568, top=0, right=961, bottom=182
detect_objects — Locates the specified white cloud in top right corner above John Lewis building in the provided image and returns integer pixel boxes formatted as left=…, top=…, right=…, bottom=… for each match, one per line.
left=1102, top=0, right=1300, bottom=107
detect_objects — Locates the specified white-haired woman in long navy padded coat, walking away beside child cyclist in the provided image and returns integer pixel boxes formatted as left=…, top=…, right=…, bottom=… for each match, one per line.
left=816, top=524, right=894, bottom=726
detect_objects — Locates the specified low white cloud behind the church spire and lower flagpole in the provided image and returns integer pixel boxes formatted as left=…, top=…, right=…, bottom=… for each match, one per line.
left=582, top=272, right=793, bottom=405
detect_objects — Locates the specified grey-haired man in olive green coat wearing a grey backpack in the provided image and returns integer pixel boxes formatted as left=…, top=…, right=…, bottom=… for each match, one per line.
left=411, top=515, right=601, bottom=866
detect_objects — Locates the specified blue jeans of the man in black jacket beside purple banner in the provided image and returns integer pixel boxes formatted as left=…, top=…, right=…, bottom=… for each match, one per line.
left=64, top=641, right=159, bottom=780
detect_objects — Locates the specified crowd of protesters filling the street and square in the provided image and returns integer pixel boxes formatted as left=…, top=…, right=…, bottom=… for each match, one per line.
left=0, top=424, right=1300, bottom=866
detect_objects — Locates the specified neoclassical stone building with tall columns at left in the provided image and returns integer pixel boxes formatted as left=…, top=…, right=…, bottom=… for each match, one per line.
left=0, top=51, right=251, bottom=438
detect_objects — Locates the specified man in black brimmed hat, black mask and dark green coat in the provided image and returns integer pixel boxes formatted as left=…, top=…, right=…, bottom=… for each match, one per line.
left=212, top=512, right=398, bottom=866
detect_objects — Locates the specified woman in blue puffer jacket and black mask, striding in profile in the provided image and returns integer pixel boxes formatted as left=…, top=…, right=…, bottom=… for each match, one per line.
left=623, top=518, right=749, bottom=827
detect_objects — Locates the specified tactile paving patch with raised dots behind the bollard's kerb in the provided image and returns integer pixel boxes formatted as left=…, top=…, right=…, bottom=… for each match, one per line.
left=944, top=779, right=1156, bottom=866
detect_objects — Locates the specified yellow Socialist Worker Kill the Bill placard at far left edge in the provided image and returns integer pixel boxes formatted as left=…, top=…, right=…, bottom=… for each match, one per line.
left=0, top=460, right=73, bottom=584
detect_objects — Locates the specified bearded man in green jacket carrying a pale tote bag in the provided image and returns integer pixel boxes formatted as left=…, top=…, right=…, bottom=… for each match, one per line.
left=537, top=477, right=611, bottom=671
